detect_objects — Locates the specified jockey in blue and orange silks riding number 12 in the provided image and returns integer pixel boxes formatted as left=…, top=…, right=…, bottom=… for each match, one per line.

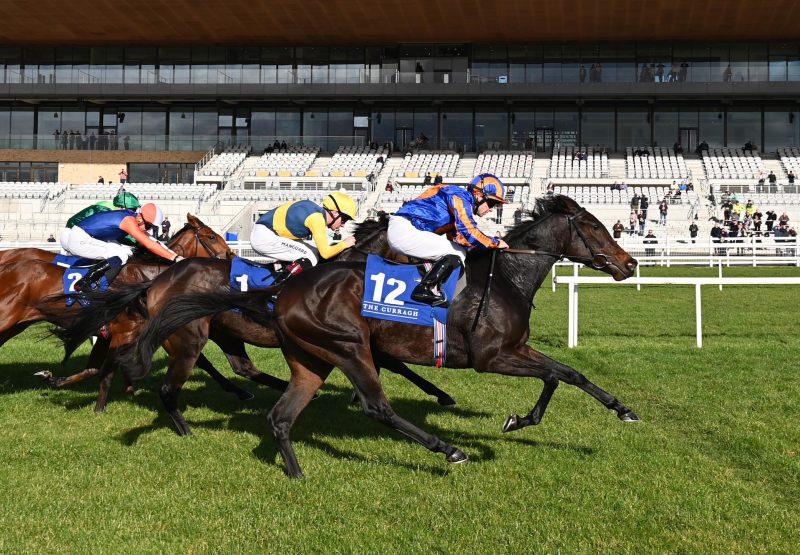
left=386, top=173, right=508, bottom=306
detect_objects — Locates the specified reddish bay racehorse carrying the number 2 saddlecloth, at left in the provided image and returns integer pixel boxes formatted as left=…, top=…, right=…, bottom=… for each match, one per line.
left=7, top=214, right=266, bottom=404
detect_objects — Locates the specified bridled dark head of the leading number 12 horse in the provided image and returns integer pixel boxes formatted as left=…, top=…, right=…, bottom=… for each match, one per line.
left=508, top=195, right=638, bottom=281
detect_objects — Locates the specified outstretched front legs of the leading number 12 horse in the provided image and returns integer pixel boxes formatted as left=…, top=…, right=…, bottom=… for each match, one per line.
left=476, top=345, right=639, bottom=432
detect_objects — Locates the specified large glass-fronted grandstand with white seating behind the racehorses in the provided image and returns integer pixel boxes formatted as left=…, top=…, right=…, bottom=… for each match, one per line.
left=0, top=0, right=800, bottom=247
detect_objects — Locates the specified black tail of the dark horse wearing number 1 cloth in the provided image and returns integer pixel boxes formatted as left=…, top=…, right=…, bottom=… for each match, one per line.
left=46, top=280, right=152, bottom=362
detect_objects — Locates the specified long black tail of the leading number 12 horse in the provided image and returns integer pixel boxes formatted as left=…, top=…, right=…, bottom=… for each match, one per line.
left=115, top=285, right=281, bottom=380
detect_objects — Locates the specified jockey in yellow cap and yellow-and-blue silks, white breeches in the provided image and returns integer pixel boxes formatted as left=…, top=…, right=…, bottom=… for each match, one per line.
left=250, top=191, right=358, bottom=283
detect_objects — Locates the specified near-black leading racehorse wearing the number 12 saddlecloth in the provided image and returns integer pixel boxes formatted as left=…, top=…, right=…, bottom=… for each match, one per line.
left=126, top=195, right=639, bottom=477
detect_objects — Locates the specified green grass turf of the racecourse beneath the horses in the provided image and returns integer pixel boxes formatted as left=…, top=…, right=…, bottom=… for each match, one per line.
left=0, top=268, right=800, bottom=554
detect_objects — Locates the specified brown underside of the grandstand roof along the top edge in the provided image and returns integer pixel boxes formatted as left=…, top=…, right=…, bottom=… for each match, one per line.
left=6, top=0, right=800, bottom=46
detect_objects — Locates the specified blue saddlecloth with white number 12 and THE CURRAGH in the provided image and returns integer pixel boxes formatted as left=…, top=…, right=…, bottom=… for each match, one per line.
left=361, top=254, right=458, bottom=326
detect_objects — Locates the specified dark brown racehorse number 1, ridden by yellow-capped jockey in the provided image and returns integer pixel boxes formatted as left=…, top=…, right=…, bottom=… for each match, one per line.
left=53, top=215, right=455, bottom=435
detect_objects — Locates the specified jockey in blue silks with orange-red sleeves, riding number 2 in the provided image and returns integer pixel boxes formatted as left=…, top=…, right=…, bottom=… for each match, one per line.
left=64, top=203, right=183, bottom=291
